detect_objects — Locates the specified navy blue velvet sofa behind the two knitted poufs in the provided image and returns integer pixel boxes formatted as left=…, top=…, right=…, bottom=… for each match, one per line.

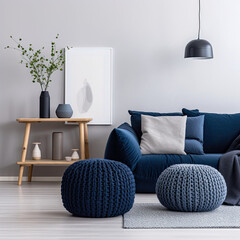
left=105, top=109, right=240, bottom=193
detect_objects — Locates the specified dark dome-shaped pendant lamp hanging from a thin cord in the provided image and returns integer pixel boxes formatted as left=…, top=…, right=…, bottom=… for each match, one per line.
left=184, top=0, right=213, bottom=59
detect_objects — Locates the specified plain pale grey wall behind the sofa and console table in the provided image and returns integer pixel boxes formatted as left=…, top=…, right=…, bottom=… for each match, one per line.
left=0, top=0, right=240, bottom=176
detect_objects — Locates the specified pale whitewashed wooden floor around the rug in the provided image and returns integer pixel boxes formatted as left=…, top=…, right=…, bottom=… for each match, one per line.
left=0, top=182, right=240, bottom=240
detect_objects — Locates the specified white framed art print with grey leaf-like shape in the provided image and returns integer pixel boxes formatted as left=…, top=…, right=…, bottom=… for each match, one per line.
left=65, top=47, right=113, bottom=125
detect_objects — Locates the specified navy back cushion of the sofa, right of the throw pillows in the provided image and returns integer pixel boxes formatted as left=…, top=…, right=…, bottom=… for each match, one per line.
left=182, top=109, right=240, bottom=153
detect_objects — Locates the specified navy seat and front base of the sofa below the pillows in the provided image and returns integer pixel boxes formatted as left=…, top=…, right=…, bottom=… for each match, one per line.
left=133, top=154, right=222, bottom=192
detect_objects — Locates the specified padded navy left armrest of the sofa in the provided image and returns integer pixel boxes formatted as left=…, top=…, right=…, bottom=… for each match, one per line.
left=104, top=125, right=141, bottom=171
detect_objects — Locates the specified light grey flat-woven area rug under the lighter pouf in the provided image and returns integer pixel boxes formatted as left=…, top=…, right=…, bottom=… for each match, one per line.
left=123, top=203, right=240, bottom=229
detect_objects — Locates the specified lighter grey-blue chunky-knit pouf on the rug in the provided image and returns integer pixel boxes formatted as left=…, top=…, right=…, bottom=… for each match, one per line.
left=156, top=164, right=227, bottom=212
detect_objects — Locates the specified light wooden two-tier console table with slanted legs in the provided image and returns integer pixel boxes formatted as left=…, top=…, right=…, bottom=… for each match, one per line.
left=17, top=118, right=92, bottom=185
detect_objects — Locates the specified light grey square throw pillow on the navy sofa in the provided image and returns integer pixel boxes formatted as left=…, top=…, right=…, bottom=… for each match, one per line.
left=140, top=115, right=187, bottom=155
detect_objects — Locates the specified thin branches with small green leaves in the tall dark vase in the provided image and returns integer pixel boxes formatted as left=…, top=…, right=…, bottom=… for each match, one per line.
left=5, top=34, right=66, bottom=91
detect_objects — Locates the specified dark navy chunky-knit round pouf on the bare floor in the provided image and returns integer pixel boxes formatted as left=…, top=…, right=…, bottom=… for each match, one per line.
left=61, top=159, right=135, bottom=218
